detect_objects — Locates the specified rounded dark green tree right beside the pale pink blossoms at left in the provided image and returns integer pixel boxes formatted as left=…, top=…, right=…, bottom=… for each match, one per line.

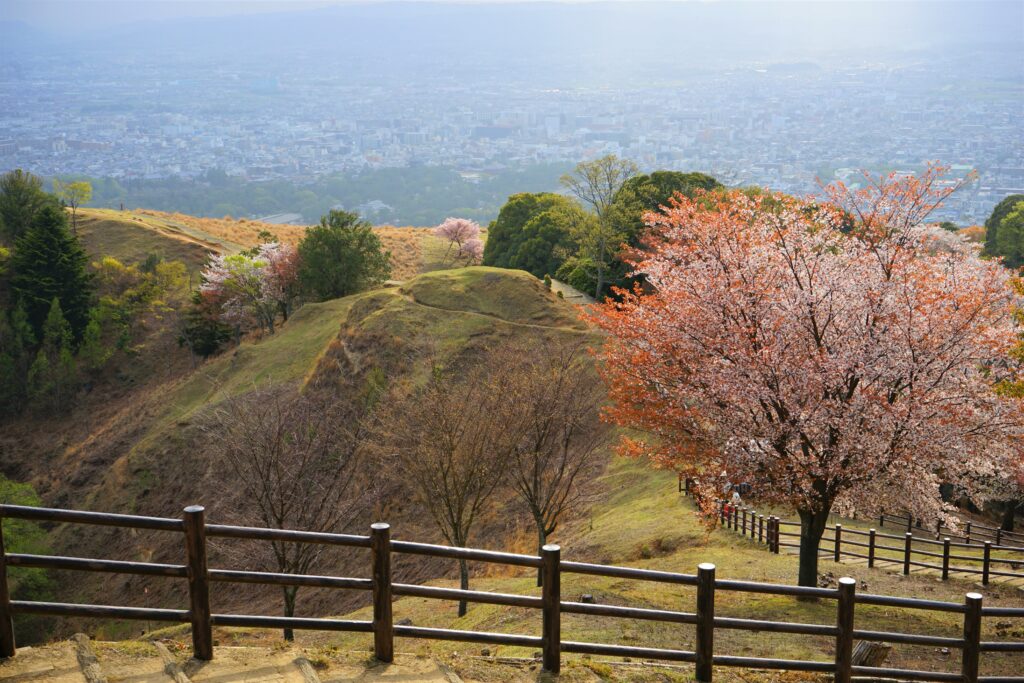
left=299, top=210, right=391, bottom=301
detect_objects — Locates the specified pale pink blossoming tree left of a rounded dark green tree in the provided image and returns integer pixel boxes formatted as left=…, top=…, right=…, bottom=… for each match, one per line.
left=200, top=242, right=298, bottom=334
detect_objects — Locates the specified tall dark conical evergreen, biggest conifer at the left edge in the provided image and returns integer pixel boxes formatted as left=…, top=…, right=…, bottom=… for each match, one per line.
left=11, top=202, right=92, bottom=341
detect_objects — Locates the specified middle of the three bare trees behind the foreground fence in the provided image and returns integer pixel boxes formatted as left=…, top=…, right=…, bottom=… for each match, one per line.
left=381, top=364, right=514, bottom=616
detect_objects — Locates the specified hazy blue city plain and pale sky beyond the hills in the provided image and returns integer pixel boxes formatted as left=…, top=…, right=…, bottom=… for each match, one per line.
left=0, top=2, right=1024, bottom=225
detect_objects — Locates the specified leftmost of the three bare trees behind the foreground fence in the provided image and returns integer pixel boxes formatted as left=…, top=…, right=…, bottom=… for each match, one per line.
left=203, top=386, right=372, bottom=640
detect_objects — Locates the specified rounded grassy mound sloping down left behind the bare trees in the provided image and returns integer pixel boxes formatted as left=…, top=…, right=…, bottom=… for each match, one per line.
left=25, top=267, right=596, bottom=635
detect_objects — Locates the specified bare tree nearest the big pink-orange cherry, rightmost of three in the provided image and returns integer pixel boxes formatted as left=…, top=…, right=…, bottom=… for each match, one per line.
left=501, top=340, right=609, bottom=585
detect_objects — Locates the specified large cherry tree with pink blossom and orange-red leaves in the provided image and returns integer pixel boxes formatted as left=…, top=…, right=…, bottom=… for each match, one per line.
left=592, top=166, right=1021, bottom=586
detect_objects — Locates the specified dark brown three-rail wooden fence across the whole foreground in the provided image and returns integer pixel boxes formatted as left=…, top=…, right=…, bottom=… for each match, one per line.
left=0, top=505, right=1024, bottom=683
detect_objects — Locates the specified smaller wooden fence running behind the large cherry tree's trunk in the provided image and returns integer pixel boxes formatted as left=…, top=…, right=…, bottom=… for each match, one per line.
left=718, top=500, right=1024, bottom=586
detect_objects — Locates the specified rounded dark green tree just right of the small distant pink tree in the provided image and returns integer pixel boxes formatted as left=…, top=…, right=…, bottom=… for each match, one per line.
left=483, top=193, right=573, bottom=278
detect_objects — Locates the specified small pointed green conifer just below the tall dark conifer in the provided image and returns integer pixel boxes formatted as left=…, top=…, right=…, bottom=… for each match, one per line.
left=29, top=297, right=77, bottom=413
